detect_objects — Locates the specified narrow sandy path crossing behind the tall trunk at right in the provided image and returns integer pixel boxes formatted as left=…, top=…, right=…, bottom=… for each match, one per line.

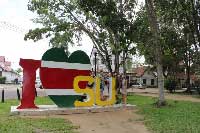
left=129, top=88, right=200, bottom=102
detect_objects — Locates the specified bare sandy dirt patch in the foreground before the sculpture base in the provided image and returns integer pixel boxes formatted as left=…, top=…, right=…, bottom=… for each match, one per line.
left=64, top=110, right=149, bottom=133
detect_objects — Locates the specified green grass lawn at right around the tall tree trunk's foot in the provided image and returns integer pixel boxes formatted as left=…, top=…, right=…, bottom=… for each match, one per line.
left=128, top=95, right=200, bottom=133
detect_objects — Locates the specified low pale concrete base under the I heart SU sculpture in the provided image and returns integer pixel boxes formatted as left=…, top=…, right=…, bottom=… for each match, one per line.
left=11, top=104, right=136, bottom=116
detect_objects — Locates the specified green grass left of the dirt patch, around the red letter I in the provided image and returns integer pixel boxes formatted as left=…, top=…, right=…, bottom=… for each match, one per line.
left=0, top=97, right=77, bottom=133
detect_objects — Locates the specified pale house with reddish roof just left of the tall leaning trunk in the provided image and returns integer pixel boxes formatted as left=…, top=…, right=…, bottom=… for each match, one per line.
left=133, top=66, right=158, bottom=87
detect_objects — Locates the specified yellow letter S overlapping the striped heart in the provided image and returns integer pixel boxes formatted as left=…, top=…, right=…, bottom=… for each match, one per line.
left=73, top=76, right=94, bottom=107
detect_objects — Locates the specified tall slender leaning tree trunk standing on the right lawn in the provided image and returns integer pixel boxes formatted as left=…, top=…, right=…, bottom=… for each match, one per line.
left=145, top=0, right=165, bottom=106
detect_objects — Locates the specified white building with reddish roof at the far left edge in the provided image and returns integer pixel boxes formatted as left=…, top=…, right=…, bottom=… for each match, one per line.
left=0, top=56, right=20, bottom=83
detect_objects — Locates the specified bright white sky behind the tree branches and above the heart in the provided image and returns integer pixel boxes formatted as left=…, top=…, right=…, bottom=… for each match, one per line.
left=0, top=0, right=144, bottom=70
